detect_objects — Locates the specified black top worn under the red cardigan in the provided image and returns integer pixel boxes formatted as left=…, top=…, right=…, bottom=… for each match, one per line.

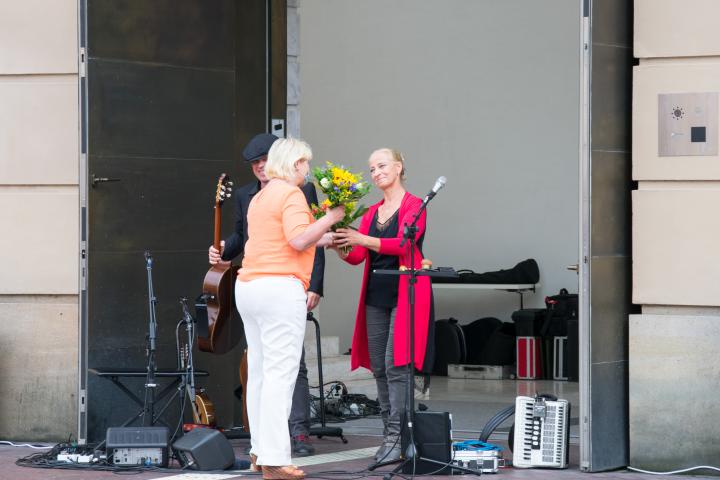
left=365, top=210, right=400, bottom=308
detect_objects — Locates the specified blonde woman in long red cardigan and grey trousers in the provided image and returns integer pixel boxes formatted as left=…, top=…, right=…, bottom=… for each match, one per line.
left=333, top=148, right=432, bottom=461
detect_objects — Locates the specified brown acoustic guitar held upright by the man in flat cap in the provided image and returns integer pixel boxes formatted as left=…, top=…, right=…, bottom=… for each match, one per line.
left=198, top=173, right=242, bottom=354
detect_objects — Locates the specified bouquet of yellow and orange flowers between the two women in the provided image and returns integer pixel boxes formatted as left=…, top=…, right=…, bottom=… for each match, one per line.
left=310, top=162, right=370, bottom=235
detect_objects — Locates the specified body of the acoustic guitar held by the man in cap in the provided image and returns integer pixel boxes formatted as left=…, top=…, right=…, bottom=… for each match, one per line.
left=198, top=265, right=242, bottom=354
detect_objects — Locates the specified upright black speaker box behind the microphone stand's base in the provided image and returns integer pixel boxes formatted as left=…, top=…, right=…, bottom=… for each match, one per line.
left=401, top=412, right=452, bottom=475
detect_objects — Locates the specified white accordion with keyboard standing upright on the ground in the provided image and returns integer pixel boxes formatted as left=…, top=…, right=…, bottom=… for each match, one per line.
left=513, top=396, right=570, bottom=468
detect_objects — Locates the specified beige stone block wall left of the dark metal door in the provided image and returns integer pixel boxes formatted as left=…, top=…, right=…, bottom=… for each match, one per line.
left=0, top=0, right=79, bottom=440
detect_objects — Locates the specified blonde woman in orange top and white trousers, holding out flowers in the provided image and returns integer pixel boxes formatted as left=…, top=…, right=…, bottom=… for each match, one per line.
left=235, top=138, right=344, bottom=479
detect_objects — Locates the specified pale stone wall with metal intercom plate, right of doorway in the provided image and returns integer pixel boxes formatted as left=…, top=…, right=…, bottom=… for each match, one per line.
left=629, top=0, right=720, bottom=470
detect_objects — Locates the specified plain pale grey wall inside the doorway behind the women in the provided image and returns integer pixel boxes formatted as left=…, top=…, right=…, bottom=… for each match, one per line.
left=299, top=0, right=580, bottom=348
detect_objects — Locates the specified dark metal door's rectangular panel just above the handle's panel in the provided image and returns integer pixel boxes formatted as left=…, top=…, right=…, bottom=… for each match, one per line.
left=89, top=60, right=235, bottom=160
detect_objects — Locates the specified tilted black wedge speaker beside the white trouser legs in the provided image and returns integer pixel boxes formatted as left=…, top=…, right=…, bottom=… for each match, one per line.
left=173, top=428, right=235, bottom=470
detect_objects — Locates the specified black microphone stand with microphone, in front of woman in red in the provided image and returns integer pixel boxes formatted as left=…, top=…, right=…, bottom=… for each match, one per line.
left=368, top=196, right=480, bottom=480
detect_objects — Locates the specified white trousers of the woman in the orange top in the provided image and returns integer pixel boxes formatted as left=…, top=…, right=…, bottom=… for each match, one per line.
left=235, top=276, right=307, bottom=465
